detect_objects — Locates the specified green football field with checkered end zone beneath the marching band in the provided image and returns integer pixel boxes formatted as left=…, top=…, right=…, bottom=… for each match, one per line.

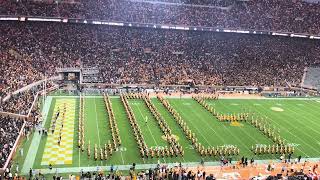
left=18, top=96, right=320, bottom=172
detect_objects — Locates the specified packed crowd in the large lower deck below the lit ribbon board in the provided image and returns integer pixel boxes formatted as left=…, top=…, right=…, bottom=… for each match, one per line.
left=0, top=22, right=320, bottom=100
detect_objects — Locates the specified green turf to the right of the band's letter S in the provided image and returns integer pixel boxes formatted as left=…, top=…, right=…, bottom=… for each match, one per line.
left=209, top=99, right=320, bottom=157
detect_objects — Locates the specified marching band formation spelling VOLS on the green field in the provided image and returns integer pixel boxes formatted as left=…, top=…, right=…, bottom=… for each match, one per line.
left=75, top=93, right=294, bottom=160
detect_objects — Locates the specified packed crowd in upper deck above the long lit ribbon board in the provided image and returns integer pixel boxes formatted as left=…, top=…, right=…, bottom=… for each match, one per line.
left=0, top=0, right=320, bottom=34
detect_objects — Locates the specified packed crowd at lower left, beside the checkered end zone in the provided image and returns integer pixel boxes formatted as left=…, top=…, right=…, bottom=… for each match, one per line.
left=0, top=116, right=23, bottom=168
